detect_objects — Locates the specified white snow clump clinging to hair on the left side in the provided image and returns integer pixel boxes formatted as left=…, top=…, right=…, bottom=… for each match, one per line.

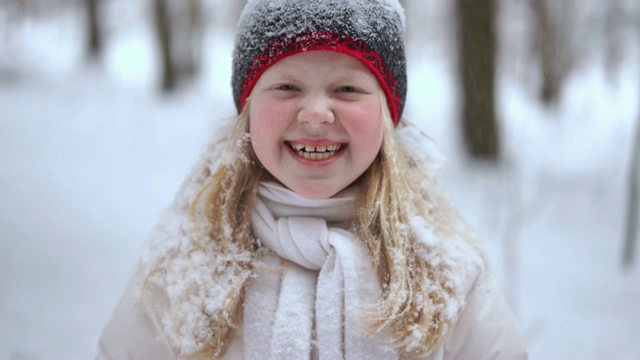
left=141, top=119, right=252, bottom=354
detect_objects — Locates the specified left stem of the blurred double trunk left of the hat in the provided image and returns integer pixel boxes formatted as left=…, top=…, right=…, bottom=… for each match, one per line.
left=154, top=0, right=177, bottom=91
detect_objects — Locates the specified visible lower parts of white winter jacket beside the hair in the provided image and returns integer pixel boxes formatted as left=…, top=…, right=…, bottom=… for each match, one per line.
left=97, top=248, right=527, bottom=360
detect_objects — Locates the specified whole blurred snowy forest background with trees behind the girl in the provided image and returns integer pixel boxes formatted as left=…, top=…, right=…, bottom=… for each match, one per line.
left=0, top=0, right=640, bottom=360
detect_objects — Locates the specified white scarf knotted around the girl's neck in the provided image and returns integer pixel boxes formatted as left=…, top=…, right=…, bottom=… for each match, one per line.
left=244, top=183, right=397, bottom=360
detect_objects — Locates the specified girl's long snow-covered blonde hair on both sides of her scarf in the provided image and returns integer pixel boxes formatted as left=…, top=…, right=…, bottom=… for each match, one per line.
left=149, top=94, right=473, bottom=358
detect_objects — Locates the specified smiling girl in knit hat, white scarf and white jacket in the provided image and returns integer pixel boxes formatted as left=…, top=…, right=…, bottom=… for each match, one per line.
left=98, top=0, right=526, bottom=360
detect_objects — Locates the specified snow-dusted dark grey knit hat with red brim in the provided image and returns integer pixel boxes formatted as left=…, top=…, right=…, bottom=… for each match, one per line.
left=232, top=0, right=407, bottom=124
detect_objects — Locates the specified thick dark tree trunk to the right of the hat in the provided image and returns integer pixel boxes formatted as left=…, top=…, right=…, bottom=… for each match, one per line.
left=457, top=0, right=500, bottom=161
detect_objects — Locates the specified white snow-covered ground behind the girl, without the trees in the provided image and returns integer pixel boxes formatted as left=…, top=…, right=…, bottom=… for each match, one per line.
left=0, top=3, right=640, bottom=360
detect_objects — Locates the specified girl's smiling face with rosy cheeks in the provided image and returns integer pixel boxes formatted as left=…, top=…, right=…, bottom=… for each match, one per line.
left=249, top=51, right=384, bottom=199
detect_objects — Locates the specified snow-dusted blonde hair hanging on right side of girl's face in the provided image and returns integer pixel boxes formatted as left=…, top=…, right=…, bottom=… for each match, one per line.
left=356, top=93, right=463, bottom=357
